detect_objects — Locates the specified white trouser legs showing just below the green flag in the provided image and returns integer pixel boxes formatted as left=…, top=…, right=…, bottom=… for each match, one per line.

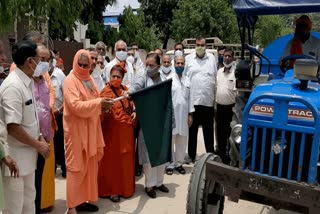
left=143, top=164, right=166, bottom=187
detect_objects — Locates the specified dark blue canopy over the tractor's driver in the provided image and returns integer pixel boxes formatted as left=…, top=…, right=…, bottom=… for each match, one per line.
left=233, top=0, right=320, bottom=16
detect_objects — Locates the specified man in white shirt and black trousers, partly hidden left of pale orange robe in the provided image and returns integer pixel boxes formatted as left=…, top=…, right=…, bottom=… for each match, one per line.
left=49, top=52, right=67, bottom=178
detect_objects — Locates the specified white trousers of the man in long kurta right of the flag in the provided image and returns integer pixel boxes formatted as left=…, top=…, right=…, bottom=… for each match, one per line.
left=167, top=134, right=188, bottom=169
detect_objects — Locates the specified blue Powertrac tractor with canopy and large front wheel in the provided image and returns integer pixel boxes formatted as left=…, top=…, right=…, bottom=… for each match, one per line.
left=187, top=0, right=320, bottom=214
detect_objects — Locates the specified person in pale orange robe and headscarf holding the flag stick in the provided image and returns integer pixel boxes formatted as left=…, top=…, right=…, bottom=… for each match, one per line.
left=63, top=50, right=112, bottom=214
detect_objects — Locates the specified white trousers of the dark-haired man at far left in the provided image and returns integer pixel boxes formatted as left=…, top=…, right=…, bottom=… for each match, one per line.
left=3, top=172, right=36, bottom=214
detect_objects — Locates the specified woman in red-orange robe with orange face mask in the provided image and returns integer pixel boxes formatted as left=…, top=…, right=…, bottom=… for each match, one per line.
left=98, top=63, right=135, bottom=202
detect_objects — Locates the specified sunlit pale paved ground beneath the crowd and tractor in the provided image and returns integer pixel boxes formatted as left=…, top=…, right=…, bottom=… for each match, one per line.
left=51, top=132, right=300, bottom=214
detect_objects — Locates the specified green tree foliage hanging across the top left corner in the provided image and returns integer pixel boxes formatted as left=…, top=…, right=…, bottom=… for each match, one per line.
left=0, top=0, right=116, bottom=40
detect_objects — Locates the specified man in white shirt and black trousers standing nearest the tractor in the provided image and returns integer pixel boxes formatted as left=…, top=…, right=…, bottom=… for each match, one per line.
left=215, top=49, right=237, bottom=164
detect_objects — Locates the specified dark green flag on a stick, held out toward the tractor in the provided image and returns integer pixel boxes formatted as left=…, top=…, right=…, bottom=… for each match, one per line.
left=130, top=79, right=173, bottom=167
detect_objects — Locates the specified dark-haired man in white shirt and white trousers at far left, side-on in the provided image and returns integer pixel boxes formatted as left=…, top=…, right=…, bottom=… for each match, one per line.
left=0, top=41, right=50, bottom=214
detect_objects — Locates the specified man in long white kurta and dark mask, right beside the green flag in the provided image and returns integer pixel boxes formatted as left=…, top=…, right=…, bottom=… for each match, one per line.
left=163, top=56, right=194, bottom=175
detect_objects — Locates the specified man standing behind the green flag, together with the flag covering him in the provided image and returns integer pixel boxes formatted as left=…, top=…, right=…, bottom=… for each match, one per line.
left=129, top=54, right=173, bottom=198
